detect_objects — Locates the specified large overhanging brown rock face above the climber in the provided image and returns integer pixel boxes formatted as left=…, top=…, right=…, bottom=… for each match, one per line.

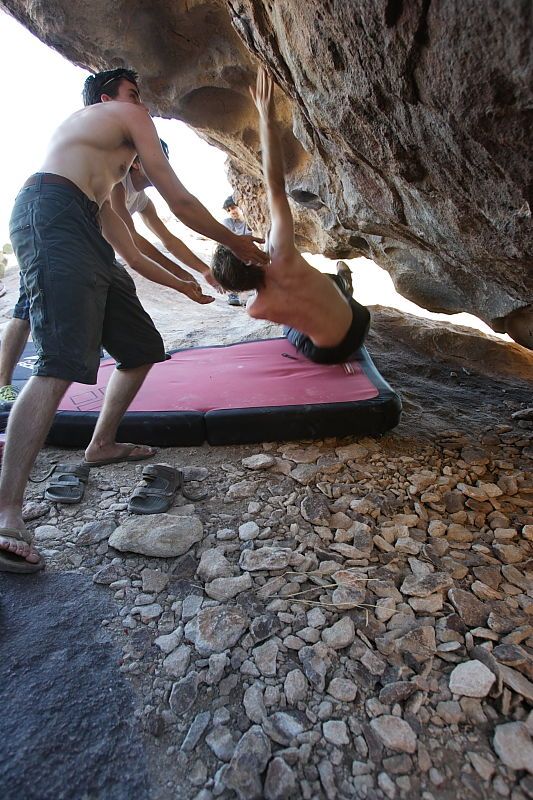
left=0, top=0, right=533, bottom=340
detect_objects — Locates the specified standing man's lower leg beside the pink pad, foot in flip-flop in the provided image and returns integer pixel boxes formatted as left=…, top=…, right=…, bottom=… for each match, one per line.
left=85, top=364, right=155, bottom=462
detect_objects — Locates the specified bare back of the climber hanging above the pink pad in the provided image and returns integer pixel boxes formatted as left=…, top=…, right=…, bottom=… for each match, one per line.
left=246, top=248, right=352, bottom=347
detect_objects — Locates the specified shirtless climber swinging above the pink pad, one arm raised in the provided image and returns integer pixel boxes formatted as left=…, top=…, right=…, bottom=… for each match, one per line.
left=211, top=68, right=370, bottom=364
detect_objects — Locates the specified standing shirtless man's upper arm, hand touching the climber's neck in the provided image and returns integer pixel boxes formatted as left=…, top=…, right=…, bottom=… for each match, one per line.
left=121, top=103, right=268, bottom=266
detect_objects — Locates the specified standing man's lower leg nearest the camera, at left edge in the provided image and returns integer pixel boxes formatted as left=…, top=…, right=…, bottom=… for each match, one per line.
left=0, top=376, right=69, bottom=563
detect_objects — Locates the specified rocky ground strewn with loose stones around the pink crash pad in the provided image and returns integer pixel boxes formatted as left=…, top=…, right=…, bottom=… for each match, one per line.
left=0, top=245, right=533, bottom=800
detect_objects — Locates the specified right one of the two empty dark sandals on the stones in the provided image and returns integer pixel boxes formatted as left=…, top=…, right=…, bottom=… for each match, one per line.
left=128, top=464, right=207, bottom=514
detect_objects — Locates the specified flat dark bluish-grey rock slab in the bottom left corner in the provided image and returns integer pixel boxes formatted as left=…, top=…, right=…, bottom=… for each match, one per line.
left=0, top=573, right=149, bottom=800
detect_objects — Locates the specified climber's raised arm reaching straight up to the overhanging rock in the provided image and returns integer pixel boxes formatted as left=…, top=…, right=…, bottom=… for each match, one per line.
left=250, top=67, right=295, bottom=258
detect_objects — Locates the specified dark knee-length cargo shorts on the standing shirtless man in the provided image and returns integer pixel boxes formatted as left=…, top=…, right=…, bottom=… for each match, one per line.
left=9, top=173, right=166, bottom=383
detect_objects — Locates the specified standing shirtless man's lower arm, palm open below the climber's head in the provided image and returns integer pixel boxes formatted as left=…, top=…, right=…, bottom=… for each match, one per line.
left=100, top=200, right=215, bottom=303
